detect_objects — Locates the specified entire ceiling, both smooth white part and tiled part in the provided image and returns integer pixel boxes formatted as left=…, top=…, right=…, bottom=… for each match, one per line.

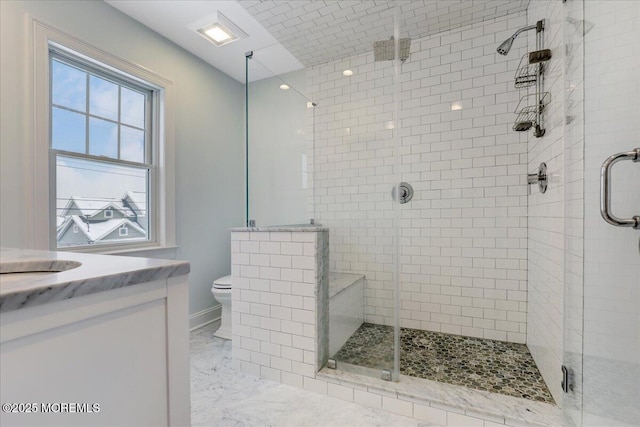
left=105, top=0, right=530, bottom=83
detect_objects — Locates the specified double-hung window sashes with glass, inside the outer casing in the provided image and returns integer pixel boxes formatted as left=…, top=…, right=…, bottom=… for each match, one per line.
left=49, top=46, right=157, bottom=248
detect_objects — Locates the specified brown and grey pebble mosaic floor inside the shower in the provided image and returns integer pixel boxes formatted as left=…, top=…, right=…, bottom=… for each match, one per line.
left=334, top=323, right=554, bottom=404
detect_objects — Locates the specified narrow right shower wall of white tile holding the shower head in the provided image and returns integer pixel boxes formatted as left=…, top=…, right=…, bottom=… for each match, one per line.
left=527, top=0, right=566, bottom=402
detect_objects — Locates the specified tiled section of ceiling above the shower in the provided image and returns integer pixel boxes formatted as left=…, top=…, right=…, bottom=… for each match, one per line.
left=238, top=0, right=529, bottom=66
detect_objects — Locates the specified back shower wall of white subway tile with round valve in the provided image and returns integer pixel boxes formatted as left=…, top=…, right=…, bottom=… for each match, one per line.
left=307, top=12, right=528, bottom=343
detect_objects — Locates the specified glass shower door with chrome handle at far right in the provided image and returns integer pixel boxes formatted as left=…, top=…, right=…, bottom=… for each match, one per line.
left=580, top=0, right=640, bottom=426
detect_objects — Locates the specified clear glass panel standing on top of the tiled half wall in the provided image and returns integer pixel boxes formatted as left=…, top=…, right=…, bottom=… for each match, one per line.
left=246, top=51, right=314, bottom=227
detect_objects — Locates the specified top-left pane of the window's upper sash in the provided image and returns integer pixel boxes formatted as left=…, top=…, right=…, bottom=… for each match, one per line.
left=51, top=60, right=87, bottom=112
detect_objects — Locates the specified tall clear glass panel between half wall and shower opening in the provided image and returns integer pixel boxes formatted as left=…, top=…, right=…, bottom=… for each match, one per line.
left=318, top=2, right=398, bottom=380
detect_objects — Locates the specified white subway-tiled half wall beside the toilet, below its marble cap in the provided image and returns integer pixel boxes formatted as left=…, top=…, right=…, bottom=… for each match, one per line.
left=231, top=231, right=326, bottom=388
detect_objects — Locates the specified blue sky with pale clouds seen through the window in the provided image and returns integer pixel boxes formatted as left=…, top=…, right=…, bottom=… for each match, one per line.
left=51, top=60, right=147, bottom=214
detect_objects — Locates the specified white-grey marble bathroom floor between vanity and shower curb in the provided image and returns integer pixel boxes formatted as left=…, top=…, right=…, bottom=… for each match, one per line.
left=190, top=322, right=432, bottom=427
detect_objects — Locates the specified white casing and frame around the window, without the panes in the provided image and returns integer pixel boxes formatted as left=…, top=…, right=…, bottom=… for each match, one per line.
left=27, top=18, right=176, bottom=253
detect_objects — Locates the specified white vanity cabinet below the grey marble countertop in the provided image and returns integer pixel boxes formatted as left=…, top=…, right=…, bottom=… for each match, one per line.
left=0, top=249, right=190, bottom=427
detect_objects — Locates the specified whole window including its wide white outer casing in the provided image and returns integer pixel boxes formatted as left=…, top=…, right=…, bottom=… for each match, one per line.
left=31, top=21, right=176, bottom=252
